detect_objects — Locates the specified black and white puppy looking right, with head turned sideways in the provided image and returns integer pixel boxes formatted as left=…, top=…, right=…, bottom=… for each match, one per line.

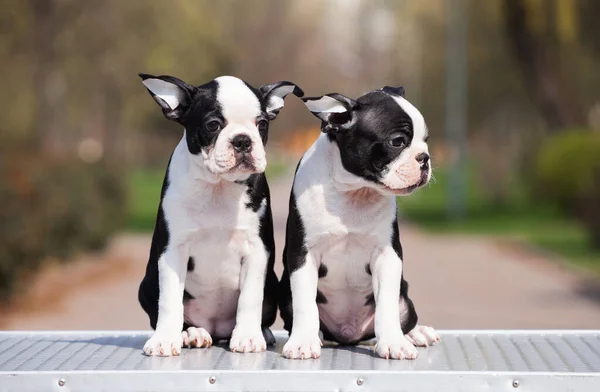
left=280, top=87, right=439, bottom=359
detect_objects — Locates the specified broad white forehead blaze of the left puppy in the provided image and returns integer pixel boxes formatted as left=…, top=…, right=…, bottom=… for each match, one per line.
left=215, top=76, right=261, bottom=123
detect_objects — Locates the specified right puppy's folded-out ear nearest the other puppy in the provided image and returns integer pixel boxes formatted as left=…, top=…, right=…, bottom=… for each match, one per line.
left=302, top=93, right=358, bottom=133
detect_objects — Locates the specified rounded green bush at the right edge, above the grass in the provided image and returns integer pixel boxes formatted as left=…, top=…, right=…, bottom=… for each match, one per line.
left=537, top=130, right=600, bottom=248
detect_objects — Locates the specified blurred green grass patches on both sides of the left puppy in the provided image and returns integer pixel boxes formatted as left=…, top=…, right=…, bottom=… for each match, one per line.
left=126, top=160, right=289, bottom=232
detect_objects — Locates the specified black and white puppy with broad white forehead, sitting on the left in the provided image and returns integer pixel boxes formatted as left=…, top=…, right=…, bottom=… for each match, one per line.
left=138, top=74, right=303, bottom=356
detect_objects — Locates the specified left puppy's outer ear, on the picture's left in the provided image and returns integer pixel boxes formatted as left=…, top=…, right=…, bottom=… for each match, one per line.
left=139, top=74, right=194, bottom=121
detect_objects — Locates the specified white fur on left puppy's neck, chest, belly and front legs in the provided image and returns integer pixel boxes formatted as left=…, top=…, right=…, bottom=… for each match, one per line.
left=144, top=136, right=269, bottom=355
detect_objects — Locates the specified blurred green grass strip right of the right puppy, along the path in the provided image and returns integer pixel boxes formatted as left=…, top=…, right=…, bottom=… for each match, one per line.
left=398, top=170, right=600, bottom=276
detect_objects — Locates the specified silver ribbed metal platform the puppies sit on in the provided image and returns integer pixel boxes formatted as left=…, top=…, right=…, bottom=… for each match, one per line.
left=0, top=331, right=600, bottom=392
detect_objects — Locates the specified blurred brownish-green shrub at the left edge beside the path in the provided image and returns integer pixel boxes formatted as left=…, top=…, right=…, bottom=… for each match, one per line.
left=0, top=152, right=124, bottom=299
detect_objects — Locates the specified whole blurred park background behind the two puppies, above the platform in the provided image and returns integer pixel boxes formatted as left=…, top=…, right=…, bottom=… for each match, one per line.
left=0, top=0, right=600, bottom=329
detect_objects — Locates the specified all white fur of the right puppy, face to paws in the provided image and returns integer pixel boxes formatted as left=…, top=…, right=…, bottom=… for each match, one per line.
left=283, top=93, right=439, bottom=359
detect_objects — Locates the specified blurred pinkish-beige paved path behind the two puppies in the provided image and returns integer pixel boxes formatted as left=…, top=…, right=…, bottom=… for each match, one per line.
left=2, top=173, right=600, bottom=330
